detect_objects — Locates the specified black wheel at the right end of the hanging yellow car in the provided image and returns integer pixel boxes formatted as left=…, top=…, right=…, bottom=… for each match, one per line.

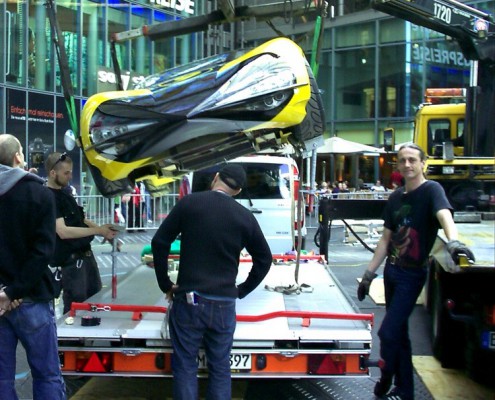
left=289, top=65, right=326, bottom=150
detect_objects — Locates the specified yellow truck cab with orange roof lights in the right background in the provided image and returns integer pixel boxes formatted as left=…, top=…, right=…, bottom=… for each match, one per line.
left=414, top=88, right=495, bottom=211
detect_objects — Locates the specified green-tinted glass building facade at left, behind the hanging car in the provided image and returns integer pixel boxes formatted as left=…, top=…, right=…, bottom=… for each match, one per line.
left=0, top=0, right=223, bottom=194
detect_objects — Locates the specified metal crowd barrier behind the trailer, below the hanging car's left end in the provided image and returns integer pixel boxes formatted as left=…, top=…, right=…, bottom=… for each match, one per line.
left=75, top=194, right=179, bottom=231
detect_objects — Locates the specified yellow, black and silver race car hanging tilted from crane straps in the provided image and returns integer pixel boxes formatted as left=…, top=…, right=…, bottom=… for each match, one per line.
left=80, top=38, right=325, bottom=197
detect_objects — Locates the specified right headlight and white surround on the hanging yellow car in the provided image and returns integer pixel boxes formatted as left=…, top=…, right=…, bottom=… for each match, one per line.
left=189, top=54, right=299, bottom=116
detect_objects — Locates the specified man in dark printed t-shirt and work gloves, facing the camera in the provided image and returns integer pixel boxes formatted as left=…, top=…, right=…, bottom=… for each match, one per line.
left=357, top=144, right=474, bottom=400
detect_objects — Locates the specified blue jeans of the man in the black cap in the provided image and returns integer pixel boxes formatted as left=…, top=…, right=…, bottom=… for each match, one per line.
left=168, top=296, right=236, bottom=400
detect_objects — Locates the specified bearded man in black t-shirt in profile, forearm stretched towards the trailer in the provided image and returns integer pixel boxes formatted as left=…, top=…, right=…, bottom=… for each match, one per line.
left=45, top=153, right=117, bottom=314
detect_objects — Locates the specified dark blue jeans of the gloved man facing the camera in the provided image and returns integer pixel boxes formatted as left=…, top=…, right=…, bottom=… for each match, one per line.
left=378, top=263, right=427, bottom=399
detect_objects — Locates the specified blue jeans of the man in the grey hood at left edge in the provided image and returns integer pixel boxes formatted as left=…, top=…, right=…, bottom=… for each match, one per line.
left=0, top=302, right=66, bottom=400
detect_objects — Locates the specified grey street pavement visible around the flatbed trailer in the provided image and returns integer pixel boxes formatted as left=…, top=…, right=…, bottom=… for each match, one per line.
left=10, top=228, right=495, bottom=400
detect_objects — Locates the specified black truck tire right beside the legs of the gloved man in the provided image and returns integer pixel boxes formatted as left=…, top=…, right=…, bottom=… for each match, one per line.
left=430, top=264, right=464, bottom=368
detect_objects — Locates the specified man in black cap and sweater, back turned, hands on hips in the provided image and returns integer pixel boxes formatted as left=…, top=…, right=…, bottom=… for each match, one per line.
left=151, top=164, right=272, bottom=400
